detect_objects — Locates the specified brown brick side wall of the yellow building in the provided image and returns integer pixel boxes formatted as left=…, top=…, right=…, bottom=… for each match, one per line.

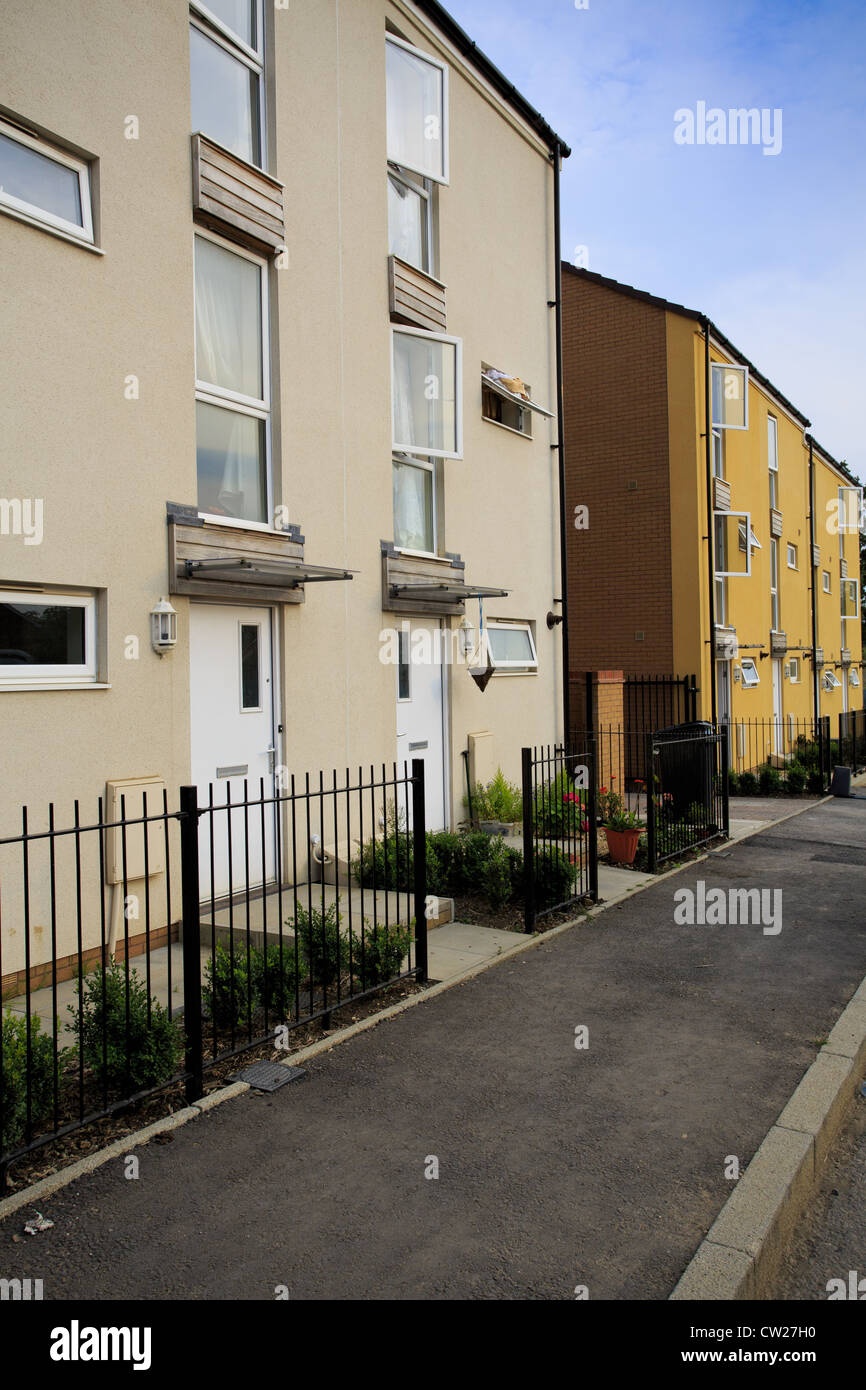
left=563, top=270, right=673, bottom=680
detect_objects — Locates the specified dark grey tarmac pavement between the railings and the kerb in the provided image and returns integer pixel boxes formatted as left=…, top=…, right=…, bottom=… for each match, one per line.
left=0, top=801, right=866, bottom=1300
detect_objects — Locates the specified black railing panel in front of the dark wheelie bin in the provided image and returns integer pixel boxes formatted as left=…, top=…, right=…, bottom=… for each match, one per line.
left=646, top=724, right=730, bottom=873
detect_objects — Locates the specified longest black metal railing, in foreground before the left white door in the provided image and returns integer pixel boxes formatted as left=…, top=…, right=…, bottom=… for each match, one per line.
left=0, top=760, right=427, bottom=1187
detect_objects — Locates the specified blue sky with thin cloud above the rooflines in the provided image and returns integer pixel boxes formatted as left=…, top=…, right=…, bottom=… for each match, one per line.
left=446, top=0, right=866, bottom=478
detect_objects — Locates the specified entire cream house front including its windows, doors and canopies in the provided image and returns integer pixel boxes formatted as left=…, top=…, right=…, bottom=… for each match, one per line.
left=0, top=0, right=567, bottom=976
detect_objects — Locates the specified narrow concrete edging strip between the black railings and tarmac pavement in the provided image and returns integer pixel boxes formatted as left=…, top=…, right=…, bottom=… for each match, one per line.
left=0, top=796, right=845, bottom=1228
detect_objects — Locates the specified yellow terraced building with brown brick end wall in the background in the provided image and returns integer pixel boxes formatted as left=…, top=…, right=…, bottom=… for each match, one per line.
left=563, top=265, right=863, bottom=769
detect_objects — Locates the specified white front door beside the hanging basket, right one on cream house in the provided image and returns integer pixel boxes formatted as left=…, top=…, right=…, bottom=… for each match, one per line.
left=398, top=620, right=446, bottom=830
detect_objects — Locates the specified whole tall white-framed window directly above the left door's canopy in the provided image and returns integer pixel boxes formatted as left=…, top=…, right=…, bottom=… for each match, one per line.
left=196, top=235, right=271, bottom=525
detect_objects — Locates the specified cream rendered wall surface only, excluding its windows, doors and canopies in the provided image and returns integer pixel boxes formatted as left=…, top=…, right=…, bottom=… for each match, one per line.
left=0, top=0, right=562, bottom=973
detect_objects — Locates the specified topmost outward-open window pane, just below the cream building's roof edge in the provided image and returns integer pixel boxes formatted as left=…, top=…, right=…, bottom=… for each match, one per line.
left=385, top=43, right=445, bottom=181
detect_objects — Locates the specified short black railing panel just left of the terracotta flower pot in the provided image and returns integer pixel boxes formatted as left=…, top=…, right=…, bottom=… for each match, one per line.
left=521, top=739, right=598, bottom=931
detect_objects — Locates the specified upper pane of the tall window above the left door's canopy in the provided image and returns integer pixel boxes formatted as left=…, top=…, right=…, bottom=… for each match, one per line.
left=196, top=236, right=263, bottom=400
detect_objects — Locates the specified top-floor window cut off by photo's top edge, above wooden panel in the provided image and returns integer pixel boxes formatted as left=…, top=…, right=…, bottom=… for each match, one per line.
left=189, top=0, right=264, bottom=168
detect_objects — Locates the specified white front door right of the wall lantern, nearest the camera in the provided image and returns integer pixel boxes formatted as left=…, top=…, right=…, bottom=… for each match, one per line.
left=189, top=603, right=278, bottom=898
